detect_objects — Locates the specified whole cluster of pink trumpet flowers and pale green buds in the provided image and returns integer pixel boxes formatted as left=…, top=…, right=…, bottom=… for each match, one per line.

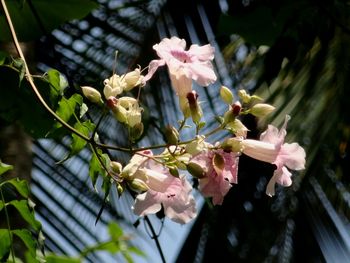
left=82, top=37, right=305, bottom=224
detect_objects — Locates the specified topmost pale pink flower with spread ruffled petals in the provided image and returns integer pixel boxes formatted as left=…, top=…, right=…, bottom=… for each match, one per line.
left=144, top=37, right=216, bottom=96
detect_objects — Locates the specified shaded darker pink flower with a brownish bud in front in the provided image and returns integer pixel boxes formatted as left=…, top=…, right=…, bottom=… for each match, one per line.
left=190, top=150, right=238, bottom=205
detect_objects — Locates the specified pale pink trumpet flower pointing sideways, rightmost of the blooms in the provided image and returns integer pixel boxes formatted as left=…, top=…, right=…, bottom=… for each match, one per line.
left=242, top=115, right=306, bottom=196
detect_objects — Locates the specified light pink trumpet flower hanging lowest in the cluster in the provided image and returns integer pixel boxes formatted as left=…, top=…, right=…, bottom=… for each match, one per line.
left=132, top=151, right=197, bottom=224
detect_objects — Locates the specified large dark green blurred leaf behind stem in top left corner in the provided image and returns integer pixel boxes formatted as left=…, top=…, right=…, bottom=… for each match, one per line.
left=0, top=0, right=99, bottom=42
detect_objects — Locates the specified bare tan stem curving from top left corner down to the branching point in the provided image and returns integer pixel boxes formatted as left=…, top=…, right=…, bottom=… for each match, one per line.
left=1, top=0, right=90, bottom=141
